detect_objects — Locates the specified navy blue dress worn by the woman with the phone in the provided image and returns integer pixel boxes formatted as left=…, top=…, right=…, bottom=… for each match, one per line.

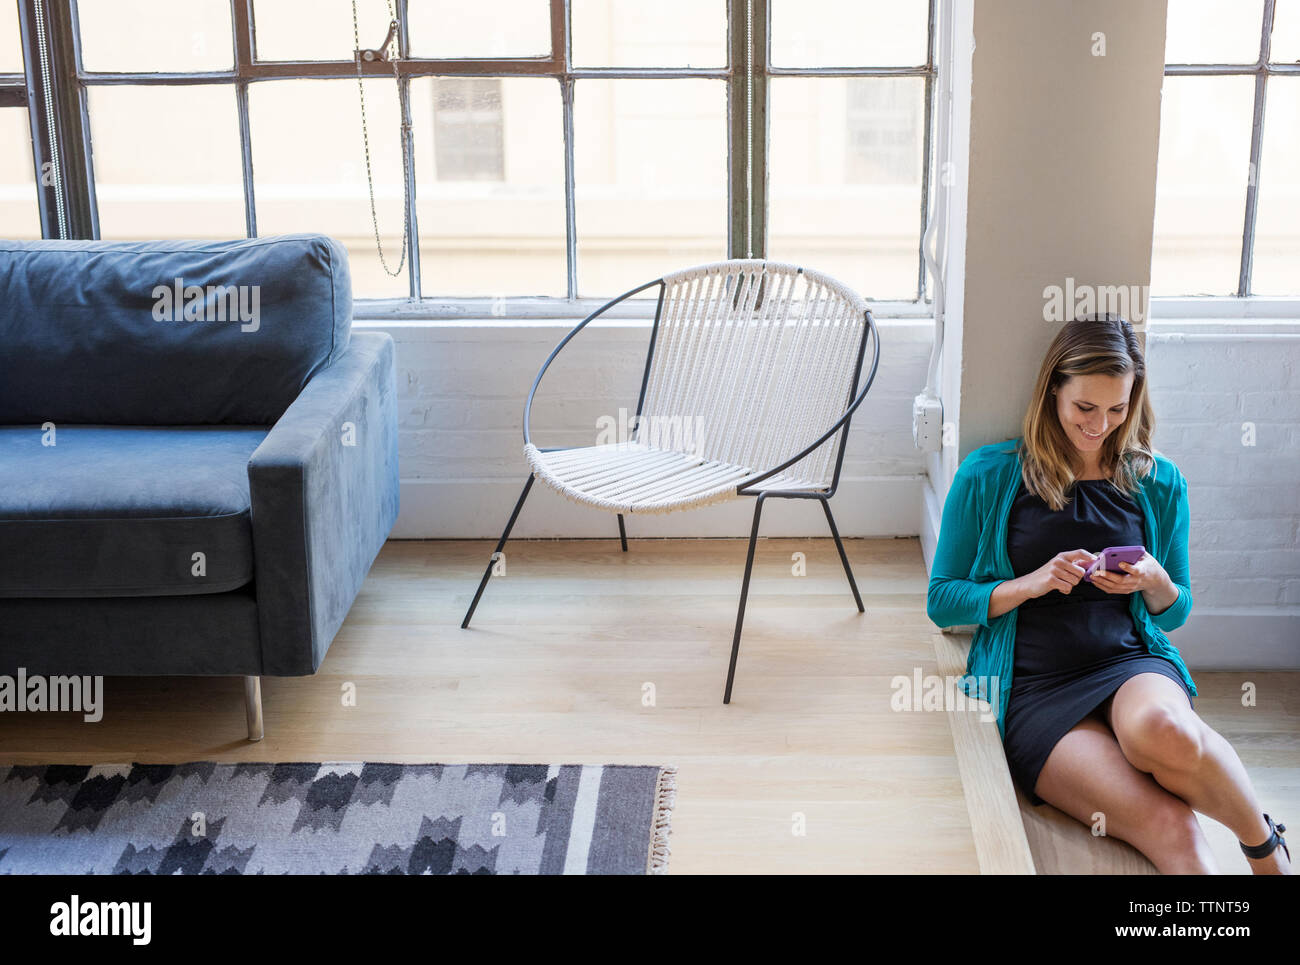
left=1002, top=479, right=1192, bottom=805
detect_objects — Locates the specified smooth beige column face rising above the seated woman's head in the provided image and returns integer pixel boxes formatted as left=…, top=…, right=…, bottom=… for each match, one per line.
left=958, top=0, right=1165, bottom=456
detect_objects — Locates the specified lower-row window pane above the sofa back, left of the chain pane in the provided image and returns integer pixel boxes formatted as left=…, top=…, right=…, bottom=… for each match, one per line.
left=88, top=83, right=247, bottom=239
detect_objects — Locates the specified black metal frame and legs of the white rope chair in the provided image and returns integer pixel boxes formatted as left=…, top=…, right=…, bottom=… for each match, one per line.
left=460, top=267, right=880, bottom=704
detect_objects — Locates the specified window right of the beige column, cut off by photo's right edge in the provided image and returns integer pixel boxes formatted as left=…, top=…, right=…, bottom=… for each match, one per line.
left=1151, top=0, right=1300, bottom=297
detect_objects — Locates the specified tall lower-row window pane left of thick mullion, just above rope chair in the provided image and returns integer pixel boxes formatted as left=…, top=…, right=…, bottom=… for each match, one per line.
left=573, top=81, right=727, bottom=295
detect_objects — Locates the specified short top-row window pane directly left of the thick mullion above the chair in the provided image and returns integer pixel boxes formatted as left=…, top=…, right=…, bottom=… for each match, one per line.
left=571, top=0, right=727, bottom=68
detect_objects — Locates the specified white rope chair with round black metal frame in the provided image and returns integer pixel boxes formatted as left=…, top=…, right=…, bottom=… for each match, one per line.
left=460, top=259, right=880, bottom=704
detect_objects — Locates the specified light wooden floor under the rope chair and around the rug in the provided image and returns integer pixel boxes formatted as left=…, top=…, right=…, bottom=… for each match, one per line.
left=0, top=538, right=1300, bottom=874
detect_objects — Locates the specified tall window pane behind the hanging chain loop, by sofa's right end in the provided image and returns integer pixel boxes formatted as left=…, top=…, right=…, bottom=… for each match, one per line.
left=248, top=77, right=410, bottom=298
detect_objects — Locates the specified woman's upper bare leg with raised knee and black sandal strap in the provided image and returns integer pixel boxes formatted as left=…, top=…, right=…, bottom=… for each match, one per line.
left=1104, top=674, right=1291, bottom=874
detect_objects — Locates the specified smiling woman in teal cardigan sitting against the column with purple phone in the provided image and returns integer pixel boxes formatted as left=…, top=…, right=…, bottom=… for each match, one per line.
left=927, top=317, right=1290, bottom=873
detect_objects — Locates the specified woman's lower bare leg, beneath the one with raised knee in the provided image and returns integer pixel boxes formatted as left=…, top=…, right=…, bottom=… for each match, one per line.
left=1034, top=714, right=1218, bottom=874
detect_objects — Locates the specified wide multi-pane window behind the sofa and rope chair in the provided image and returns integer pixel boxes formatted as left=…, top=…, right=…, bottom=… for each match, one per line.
left=0, top=0, right=937, bottom=313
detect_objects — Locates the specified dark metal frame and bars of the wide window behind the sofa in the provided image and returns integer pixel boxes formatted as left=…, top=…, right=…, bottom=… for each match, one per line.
left=15, top=0, right=940, bottom=317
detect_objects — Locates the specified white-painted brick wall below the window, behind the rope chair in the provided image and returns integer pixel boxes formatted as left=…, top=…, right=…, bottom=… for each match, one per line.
left=356, top=319, right=933, bottom=538
